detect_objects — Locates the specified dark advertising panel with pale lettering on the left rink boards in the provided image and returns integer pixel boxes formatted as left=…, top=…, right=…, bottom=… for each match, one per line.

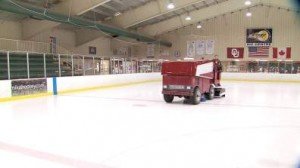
left=11, top=79, right=47, bottom=96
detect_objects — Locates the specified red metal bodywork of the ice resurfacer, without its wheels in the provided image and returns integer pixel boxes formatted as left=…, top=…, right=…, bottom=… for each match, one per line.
left=162, top=60, right=221, bottom=96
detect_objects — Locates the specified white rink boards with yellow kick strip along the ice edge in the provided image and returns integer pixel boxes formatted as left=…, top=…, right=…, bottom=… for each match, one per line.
left=0, top=73, right=300, bottom=102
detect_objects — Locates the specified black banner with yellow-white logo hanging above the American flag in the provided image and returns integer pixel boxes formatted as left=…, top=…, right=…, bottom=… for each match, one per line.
left=246, top=29, right=272, bottom=46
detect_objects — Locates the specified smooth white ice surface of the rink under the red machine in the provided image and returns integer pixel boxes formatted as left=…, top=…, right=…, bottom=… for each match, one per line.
left=0, top=82, right=300, bottom=168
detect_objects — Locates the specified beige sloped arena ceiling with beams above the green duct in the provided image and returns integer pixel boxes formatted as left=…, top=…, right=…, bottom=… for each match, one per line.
left=0, top=0, right=296, bottom=41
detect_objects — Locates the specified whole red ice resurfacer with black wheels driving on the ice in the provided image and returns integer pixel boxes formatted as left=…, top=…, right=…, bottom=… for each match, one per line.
left=161, top=59, right=225, bottom=105
